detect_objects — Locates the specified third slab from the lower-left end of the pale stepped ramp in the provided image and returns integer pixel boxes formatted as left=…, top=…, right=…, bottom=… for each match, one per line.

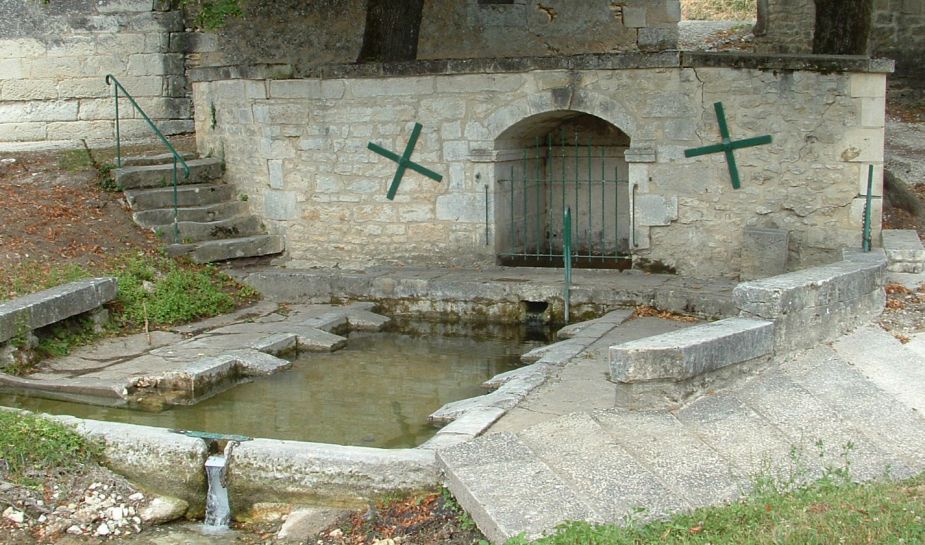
left=594, top=409, right=748, bottom=508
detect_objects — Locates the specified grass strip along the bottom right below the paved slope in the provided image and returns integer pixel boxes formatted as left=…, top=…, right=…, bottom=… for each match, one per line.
left=507, top=471, right=925, bottom=545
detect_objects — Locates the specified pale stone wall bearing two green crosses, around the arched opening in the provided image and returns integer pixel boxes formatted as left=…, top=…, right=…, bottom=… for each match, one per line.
left=191, top=53, right=890, bottom=277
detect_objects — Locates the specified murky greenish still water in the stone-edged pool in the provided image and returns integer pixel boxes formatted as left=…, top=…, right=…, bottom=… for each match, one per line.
left=0, top=328, right=544, bottom=448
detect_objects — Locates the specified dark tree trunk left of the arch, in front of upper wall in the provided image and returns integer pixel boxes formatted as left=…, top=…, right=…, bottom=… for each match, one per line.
left=357, top=0, right=424, bottom=62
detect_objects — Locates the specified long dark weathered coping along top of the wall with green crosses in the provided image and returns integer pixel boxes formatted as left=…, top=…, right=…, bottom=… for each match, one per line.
left=189, top=50, right=895, bottom=82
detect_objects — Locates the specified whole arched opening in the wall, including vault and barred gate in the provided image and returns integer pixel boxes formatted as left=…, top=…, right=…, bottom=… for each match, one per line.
left=490, top=105, right=632, bottom=267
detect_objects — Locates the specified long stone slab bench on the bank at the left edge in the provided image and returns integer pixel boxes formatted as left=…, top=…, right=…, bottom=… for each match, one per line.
left=0, top=277, right=116, bottom=343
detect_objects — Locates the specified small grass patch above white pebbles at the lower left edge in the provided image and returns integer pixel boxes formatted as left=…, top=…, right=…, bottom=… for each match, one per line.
left=0, top=411, right=100, bottom=484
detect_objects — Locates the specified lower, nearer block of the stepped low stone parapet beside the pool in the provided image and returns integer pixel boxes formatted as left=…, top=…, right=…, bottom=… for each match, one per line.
left=610, top=318, right=774, bottom=409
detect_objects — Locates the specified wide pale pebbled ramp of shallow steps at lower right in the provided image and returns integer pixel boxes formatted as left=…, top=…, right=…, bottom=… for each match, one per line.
left=437, top=329, right=925, bottom=543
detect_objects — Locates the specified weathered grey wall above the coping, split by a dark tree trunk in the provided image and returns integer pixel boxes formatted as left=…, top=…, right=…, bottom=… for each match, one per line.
left=188, top=0, right=681, bottom=77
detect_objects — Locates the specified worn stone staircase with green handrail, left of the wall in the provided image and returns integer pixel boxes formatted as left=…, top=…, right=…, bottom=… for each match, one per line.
left=113, top=154, right=285, bottom=263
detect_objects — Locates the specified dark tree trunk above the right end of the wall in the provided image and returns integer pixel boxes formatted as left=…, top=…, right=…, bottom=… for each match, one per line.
left=813, top=0, right=874, bottom=55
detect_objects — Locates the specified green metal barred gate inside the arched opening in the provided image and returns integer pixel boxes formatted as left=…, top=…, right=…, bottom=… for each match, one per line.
left=495, top=133, right=631, bottom=268
